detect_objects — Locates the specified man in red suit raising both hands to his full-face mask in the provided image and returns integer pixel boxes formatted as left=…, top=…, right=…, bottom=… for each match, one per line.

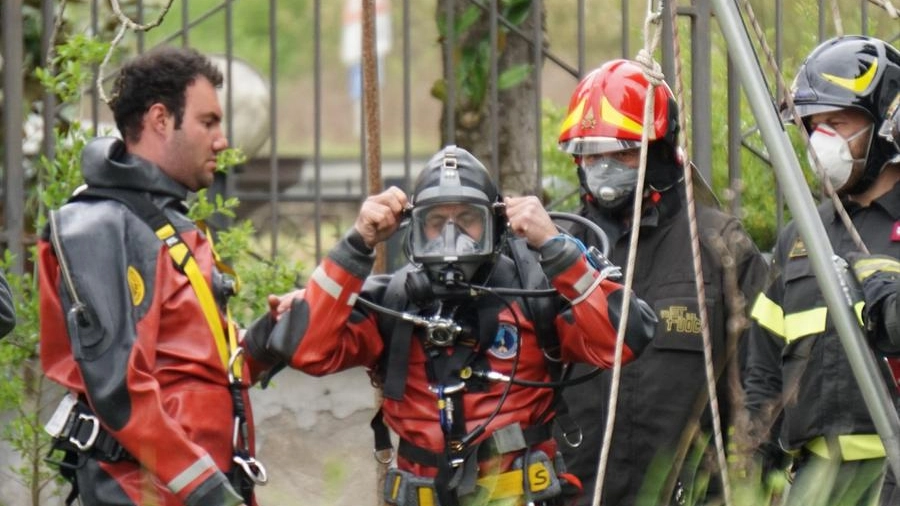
left=243, top=146, right=656, bottom=506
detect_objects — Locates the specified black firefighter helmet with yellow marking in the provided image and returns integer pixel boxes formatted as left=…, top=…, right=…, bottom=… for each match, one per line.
left=781, top=35, right=900, bottom=193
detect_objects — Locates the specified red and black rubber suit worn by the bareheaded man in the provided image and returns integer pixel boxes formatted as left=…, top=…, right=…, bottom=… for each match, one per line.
left=38, top=139, right=266, bottom=506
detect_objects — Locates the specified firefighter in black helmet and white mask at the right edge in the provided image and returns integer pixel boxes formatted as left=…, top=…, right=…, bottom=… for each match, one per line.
left=744, top=36, right=900, bottom=506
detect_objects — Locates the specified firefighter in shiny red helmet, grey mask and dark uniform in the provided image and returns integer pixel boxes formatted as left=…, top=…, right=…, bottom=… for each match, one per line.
left=559, top=60, right=766, bottom=506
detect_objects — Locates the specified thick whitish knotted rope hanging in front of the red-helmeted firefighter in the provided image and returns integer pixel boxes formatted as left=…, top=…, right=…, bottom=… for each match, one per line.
left=591, top=0, right=664, bottom=506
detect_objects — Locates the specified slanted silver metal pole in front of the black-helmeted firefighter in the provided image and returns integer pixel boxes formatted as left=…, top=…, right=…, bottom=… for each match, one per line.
left=712, top=0, right=900, bottom=476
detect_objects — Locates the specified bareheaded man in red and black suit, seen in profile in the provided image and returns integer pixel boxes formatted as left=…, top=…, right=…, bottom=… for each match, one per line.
left=38, top=48, right=265, bottom=506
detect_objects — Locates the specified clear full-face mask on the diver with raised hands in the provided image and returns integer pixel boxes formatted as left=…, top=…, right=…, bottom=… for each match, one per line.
left=410, top=202, right=494, bottom=285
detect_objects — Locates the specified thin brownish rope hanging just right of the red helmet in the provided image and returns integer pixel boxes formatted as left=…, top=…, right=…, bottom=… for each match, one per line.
left=665, top=2, right=732, bottom=506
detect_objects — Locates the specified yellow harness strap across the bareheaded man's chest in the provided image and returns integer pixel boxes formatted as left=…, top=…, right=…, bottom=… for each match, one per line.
left=156, top=224, right=243, bottom=379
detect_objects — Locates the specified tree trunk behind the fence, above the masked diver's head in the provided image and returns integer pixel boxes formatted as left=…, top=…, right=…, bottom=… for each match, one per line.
left=436, top=0, right=545, bottom=195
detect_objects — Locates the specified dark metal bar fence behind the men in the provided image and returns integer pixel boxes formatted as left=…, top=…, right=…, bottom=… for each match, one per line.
left=0, top=0, right=900, bottom=272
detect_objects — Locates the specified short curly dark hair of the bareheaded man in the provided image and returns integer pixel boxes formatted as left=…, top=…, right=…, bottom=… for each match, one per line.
left=109, top=46, right=223, bottom=142
